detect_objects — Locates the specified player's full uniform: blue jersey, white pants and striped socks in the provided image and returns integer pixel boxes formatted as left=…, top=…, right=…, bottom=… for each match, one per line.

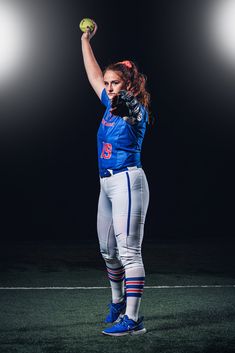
left=97, top=89, right=149, bottom=317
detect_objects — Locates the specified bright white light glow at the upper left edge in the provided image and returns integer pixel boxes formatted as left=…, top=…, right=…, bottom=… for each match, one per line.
left=0, top=1, right=30, bottom=88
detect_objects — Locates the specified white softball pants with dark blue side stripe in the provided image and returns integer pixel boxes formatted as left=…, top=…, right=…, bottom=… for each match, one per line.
left=97, top=168, right=149, bottom=269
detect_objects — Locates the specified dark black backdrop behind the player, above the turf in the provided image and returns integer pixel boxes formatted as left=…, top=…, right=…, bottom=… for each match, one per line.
left=0, top=0, right=235, bottom=242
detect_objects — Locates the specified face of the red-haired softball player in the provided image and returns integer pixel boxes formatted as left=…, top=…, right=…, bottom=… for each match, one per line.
left=104, top=70, right=127, bottom=99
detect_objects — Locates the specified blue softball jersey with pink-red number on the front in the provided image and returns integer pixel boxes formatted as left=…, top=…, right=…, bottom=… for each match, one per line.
left=97, top=89, right=148, bottom=177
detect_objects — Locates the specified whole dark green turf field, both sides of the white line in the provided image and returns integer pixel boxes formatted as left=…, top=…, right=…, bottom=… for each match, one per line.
left=0, top=239, right=235, bottom=353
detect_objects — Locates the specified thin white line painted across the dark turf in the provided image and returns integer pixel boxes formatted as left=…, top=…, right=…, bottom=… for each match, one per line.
left=0, top=284, right=235, bottom=290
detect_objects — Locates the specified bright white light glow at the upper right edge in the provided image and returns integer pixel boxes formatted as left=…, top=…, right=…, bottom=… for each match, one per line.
left=209, top=0, right=235, bottom=68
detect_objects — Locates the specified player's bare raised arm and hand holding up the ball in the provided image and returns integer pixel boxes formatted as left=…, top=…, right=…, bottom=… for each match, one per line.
left=81, top=22, right=105, bottom=98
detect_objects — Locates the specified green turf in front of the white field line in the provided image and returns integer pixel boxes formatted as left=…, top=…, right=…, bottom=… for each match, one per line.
left=0, top=288, right=235, bottom=353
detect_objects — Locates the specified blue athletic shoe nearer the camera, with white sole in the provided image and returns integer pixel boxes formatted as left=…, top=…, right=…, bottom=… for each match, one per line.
left=102, top=315, right=146, bottom=336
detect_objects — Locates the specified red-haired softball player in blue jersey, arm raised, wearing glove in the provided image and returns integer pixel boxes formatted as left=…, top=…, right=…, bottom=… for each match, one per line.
left=81, top=19, right=150, bottom=336
